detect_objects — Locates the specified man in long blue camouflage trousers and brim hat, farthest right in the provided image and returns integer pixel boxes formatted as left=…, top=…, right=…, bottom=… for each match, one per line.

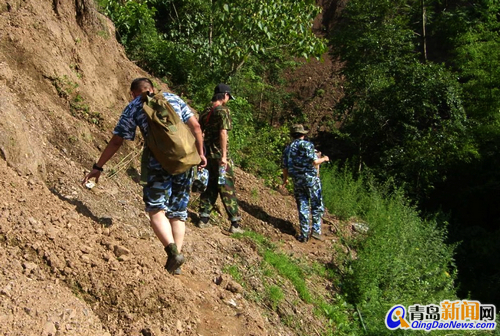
left=282, top=125, right=329, bottom=243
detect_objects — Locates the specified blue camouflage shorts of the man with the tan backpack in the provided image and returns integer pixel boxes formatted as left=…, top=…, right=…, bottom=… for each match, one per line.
left=142, top=169, right=193, bottom=221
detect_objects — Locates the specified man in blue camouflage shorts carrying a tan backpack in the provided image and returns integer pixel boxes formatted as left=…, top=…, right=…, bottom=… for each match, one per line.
left=83, top=78, right=206, bottom=274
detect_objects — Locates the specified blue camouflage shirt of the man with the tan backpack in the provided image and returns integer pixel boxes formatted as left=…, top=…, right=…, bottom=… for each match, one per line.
left=113, top=92, right=193, bottom=169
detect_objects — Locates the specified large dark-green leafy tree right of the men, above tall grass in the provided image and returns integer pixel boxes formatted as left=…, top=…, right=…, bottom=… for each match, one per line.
left=333, top=0, right=477, bottom=198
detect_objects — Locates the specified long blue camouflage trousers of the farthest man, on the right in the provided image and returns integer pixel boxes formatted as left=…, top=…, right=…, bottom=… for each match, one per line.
left=293, top=177, right=325, bottom=237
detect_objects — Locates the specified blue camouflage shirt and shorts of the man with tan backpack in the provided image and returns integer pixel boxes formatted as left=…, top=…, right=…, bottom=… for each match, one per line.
left=113, top=93, right=193, bottom=220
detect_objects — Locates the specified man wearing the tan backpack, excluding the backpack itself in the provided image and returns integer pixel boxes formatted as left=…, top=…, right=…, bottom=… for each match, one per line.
left=83, top=78, right=206, bottom=274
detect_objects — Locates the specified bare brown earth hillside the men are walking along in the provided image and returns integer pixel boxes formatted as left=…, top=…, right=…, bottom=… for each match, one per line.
left=0, top=0, right=342, bottom=336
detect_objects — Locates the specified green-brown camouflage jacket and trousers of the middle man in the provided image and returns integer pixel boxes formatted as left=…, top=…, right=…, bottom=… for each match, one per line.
left=199, top=105, right=241, bottom=222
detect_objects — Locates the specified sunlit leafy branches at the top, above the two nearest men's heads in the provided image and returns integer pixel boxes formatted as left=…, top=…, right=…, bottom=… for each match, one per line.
left=99, top=0, right=326, bottom=93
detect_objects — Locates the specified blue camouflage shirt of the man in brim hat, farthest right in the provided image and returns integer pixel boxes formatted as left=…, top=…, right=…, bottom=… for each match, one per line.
left=282, top=139, right=318, bottom=183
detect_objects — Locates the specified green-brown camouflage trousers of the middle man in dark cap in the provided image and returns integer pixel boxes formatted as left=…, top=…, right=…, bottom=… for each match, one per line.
left=199, top=158, right=241, bottom=222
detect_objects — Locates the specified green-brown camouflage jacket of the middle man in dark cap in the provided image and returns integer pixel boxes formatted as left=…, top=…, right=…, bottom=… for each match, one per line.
left=200, top=105, right=232, bottom=159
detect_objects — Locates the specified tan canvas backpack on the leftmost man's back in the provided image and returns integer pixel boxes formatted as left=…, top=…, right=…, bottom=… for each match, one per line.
left=141, top=92, right=201, bottom=175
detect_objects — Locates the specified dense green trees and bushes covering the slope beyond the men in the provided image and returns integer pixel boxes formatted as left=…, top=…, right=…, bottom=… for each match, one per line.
left=95, top=0, right=500, bottom=334
